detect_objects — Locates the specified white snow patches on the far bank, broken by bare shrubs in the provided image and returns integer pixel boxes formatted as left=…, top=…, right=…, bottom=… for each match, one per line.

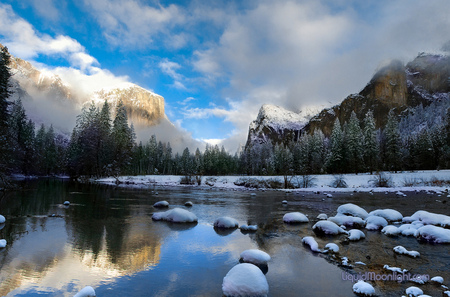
left=95, top=170, right=450, bottom=192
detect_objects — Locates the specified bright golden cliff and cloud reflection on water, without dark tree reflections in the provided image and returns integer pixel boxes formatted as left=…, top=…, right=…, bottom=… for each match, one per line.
left=0, top=214, right=162, bottom=296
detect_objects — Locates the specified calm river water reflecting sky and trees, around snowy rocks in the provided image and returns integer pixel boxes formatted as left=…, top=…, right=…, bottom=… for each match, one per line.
left=0, top=180, right=450, bottom=297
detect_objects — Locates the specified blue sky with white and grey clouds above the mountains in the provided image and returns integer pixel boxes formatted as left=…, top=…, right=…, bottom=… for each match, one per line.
left=0, top=0, right=450, bottom=151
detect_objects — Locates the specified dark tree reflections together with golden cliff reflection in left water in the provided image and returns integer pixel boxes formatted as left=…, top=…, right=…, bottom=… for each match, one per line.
left=0, top=180, right=167, bottom=296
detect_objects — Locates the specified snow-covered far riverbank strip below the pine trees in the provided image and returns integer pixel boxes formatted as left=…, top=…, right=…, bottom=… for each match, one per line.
left=95, top=170, right=450, bottom=192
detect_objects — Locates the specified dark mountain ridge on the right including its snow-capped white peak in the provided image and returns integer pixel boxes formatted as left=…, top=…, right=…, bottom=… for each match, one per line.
left=247, top=53, right=450, bottom=146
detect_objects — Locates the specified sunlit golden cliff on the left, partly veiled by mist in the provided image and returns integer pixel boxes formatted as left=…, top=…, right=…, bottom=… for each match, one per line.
left=4, top=46, right=165, bottom=131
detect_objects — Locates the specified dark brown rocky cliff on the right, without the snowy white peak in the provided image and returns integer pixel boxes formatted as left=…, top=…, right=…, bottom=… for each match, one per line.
left=247, top=54, right=450, bottom=145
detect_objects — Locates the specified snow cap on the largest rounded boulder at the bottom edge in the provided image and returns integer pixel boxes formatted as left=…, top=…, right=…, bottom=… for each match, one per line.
left=222, top=263, right=269, bottom=296
